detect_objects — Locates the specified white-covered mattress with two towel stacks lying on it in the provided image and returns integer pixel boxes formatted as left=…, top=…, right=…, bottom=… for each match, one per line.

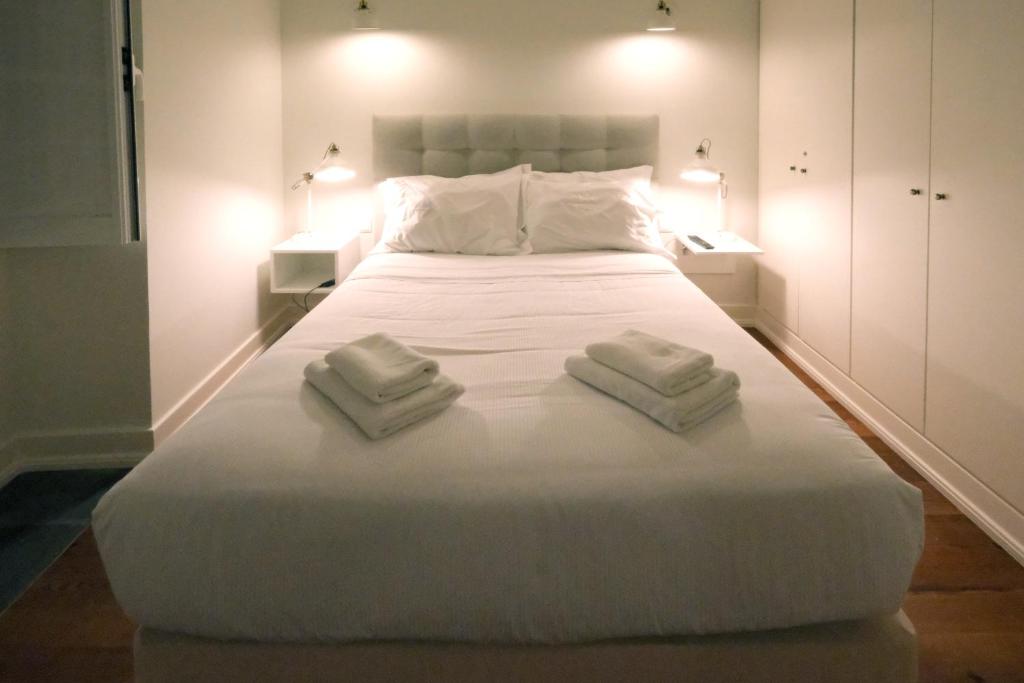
left=93, top=252, right=923, bottom=642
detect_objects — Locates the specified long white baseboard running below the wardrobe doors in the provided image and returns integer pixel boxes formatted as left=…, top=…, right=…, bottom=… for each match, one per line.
left=756, top=310, right=1024, bottom=564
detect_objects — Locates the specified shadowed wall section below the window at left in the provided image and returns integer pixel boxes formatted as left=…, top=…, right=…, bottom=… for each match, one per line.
left=0, top=245, right=150, bottom=473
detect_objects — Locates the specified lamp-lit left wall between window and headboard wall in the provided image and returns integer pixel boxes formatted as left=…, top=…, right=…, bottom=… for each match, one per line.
left=142, top=0, right=285, bottom=435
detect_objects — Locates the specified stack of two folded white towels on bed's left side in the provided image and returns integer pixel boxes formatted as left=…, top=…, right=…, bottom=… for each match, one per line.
left=305, top=333, right=466, bottom=439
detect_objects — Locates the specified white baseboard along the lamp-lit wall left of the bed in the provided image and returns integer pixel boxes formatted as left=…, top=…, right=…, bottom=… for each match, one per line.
left=153, top=306, right=300, bottom=446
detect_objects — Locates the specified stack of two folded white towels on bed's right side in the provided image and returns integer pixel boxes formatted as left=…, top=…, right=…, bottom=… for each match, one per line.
left=565, top=330, right=739, bottom=432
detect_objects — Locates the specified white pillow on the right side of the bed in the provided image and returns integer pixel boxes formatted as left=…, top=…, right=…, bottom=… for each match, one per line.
left=525, top=176, right=673, bottom=258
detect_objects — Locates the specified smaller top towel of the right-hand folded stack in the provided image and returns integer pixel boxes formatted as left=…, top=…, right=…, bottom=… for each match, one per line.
left=586, top=330, right=715, bottom=396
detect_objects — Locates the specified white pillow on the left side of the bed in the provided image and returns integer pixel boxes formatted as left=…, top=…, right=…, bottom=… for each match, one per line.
left=381, top=165, right=530, bottom=255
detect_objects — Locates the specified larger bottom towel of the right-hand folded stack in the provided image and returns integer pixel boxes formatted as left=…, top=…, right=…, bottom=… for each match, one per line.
left=565, top=355, right=739, bottom=432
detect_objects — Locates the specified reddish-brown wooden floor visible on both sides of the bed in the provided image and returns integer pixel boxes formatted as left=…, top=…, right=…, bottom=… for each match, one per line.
left=0, top=333, right=1024, bottom=683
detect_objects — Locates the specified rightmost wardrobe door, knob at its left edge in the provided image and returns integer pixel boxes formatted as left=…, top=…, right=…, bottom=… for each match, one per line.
left=925, top=0, right=1024, bottom=510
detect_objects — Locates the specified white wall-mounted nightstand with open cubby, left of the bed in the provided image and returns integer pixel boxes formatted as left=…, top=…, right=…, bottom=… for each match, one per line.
left=270, top=232, right=367, bottom=294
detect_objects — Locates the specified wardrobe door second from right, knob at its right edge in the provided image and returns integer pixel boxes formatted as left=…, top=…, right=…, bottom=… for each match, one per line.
left=850, top=0, right=932, bottom=431
